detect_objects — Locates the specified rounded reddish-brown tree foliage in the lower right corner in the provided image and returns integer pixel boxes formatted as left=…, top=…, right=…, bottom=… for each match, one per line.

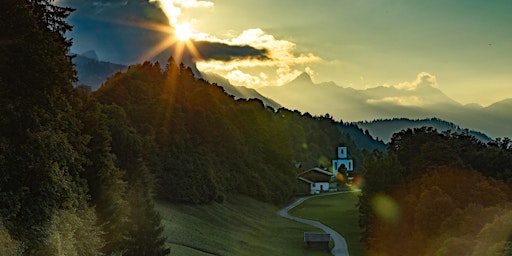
left=369, top=167, right=512, bottom=255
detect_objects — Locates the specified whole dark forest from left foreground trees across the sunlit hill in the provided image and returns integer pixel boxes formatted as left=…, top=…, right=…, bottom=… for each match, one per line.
left=0, top=0, right=363, bottom=255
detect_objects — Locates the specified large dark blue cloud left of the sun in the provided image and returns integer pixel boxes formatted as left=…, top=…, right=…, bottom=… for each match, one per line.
left=59, top=0, right=168, bottom=64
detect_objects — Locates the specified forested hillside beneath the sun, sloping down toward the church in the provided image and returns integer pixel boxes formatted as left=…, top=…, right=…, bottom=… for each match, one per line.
left=94, top=58, right=348, bottom=204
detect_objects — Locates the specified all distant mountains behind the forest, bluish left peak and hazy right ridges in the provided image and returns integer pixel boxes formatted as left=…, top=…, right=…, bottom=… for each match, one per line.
left=74, top=51, right=512, bottom=142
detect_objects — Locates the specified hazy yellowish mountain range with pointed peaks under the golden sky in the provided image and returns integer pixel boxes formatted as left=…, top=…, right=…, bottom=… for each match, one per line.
left=256, top=73, right=512, bottom=138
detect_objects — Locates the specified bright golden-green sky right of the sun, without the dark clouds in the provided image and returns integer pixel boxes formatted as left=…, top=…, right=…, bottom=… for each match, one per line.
left=147, top=0, right=512, bottom=105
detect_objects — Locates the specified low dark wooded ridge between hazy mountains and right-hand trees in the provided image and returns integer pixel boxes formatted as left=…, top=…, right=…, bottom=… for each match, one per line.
left=353, top=118, right=492, bottom=143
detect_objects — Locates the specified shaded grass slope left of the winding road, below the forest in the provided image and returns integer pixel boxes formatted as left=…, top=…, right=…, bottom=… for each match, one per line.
left=156, top=196, right=330, bottom=256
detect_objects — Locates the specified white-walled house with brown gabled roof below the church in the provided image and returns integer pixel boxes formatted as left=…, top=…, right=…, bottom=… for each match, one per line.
left=297, top=167, right=333, bottom=195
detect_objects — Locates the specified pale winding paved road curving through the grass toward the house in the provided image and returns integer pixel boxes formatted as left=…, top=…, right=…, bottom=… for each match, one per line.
left=278, top=192, right=349, bottom=256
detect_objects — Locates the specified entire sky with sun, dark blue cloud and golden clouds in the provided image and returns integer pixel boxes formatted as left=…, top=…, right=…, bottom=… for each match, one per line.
left=57, top=0, right=512, bottom=106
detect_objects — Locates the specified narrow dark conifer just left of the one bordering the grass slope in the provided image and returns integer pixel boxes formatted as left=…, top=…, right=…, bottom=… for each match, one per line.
left=80, top=89, right=129, bottom=255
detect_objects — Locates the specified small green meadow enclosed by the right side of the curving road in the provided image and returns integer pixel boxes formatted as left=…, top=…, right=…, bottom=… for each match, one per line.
left=290, top=193, right=366, bottom=256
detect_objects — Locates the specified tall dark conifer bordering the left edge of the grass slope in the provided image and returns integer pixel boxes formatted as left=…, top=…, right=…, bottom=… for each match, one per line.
left=104, top=105, right=169, bottom=255
